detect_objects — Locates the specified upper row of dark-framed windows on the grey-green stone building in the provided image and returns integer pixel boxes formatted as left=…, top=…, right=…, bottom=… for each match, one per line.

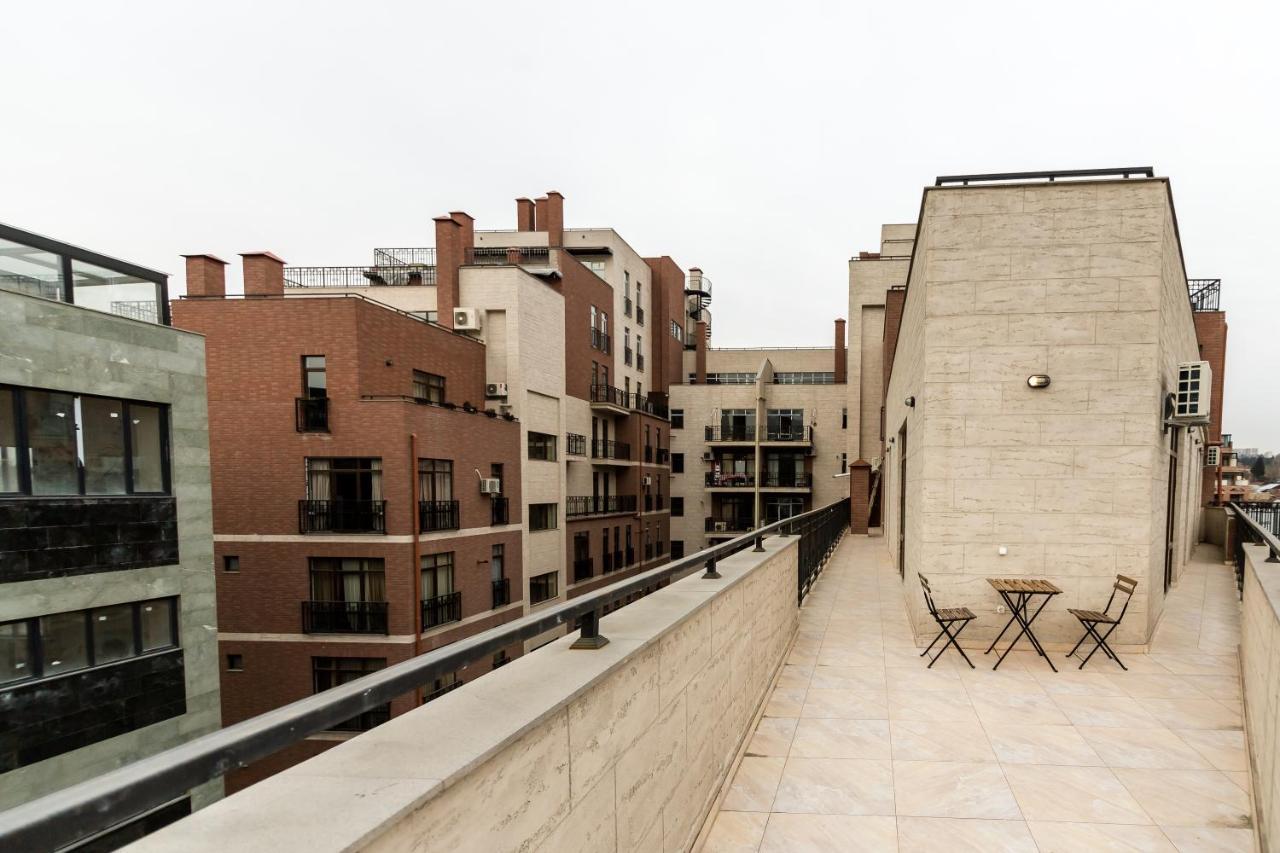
left=0, top=387, right=169, bottom=496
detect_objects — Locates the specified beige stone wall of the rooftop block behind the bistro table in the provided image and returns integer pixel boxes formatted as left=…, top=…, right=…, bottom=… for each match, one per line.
left=886, top=179, right=1199, bottom=643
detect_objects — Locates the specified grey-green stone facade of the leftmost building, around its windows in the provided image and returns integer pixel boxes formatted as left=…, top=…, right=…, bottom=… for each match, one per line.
left=0, top=291, right=221, bottom=808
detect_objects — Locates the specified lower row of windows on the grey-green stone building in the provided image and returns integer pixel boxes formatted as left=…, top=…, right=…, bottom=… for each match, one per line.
left=0, top=598, right=178, bottom=684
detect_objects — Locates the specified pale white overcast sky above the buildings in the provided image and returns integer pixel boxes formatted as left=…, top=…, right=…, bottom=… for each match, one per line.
left=0, top=0, right=1280, bottom=451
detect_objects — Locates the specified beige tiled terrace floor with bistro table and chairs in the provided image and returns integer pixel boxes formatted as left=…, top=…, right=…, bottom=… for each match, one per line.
left=704, top=537, right=1252, bottom=853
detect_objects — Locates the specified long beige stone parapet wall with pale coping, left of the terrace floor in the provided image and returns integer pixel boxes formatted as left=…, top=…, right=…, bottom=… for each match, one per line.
left=128, top=538, right=797, bottom=853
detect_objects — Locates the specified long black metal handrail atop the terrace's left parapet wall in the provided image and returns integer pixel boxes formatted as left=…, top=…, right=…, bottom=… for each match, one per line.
left=0, top=500, right=849, bottom=850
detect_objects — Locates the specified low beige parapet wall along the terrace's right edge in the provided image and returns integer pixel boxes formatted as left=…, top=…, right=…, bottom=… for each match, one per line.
left=1240, top=544, right=1280, bottom=849
